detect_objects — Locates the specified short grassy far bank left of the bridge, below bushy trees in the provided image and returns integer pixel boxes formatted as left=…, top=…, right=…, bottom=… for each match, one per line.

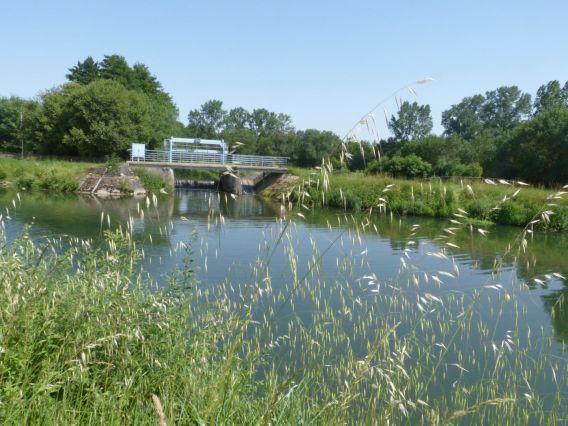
left=0, top=157, right=95, bottom=192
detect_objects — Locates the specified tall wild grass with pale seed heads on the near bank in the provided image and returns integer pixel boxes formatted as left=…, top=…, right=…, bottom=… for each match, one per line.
left=0, top=192, right=568, bottom=425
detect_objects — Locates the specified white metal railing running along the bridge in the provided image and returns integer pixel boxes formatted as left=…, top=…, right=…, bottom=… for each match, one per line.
left=130, top=149, right=288, bottom=169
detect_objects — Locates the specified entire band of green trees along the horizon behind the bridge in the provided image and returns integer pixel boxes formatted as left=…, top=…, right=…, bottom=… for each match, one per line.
left=0, top=55, right=568, bottom=184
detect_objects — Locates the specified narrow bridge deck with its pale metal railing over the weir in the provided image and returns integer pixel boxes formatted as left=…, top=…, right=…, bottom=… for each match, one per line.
left=128, top=150, right=288, bottom=173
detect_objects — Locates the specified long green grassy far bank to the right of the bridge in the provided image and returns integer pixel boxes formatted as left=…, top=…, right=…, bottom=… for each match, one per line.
left=291, top=168, right=568, bottom=231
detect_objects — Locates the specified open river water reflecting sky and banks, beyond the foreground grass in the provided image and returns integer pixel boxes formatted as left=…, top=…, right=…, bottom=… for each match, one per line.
left=0, top=191, right=568, bottom=343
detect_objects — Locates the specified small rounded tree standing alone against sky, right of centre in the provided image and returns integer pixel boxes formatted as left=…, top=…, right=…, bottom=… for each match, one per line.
left=389, top=101, right=433, bottom=142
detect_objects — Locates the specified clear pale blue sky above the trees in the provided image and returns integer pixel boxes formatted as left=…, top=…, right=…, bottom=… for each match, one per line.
left=0, top=0, right=568, bottom=136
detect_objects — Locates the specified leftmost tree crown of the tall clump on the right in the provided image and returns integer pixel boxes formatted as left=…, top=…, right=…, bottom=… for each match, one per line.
left=442, top=95, right=485, bottom=140
